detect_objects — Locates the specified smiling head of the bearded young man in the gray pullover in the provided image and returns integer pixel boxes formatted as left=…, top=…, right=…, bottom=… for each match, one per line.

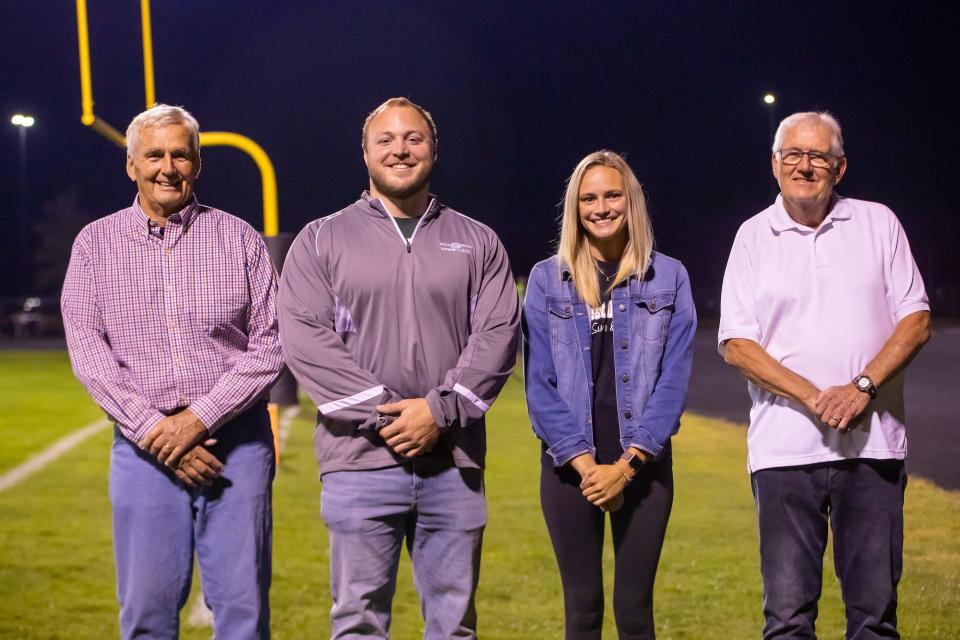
left=363, top=106, right=435, bottom=200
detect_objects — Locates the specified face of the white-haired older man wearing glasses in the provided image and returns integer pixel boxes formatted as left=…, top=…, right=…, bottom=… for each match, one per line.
left=771, top=119, right=847, bottom=223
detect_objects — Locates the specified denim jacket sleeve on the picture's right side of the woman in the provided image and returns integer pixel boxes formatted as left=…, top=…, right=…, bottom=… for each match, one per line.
left=630, top=265, right=697, bottom=456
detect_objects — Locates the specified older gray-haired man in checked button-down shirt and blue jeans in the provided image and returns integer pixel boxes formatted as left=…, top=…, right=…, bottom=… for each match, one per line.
left=62, top=105, right=282, bottom=639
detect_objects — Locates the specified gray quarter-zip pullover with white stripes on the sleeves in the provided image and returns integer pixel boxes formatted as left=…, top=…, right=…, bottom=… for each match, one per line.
left=279, top=192, right=520, bottom=474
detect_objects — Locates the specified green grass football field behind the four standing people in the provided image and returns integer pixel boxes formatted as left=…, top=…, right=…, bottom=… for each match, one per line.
left=0, top=353, right=960, bottom=640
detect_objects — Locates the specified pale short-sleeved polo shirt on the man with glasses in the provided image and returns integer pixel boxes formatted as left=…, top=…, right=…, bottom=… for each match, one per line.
left=718, top=196, right=930, bottom=472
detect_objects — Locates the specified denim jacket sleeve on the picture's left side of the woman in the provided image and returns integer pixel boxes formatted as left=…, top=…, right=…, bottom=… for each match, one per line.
left=522, top=265, right=590, bottom=467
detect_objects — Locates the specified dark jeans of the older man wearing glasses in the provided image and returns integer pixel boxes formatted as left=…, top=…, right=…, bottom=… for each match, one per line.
left=753, top=458, right=907, bottom=640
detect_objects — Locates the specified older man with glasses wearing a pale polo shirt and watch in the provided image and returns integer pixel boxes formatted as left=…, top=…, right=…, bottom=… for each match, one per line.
left=719, top=112, right=930, bottom=639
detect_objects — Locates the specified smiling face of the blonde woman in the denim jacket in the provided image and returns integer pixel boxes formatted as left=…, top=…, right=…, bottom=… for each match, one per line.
left=577, top=165, right=627, bottom=260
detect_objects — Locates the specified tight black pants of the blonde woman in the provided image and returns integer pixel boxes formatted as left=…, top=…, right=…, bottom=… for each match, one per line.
left=540, top=450, right=673, bottom=640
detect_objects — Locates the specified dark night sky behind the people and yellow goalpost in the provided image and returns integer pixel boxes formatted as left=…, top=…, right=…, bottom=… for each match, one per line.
left=0, top=0, right=960, bottom=314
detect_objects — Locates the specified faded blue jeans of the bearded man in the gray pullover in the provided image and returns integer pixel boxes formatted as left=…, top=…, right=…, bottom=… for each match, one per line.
left=321, top=462, right=487, bottom=640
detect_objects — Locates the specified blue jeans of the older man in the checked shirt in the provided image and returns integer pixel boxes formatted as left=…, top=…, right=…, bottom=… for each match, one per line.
left=110, top=407, right=275, bottom=640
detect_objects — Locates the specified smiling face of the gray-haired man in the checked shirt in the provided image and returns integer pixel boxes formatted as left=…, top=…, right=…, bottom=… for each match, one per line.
left=127, top=124, right=200, bottom=218
